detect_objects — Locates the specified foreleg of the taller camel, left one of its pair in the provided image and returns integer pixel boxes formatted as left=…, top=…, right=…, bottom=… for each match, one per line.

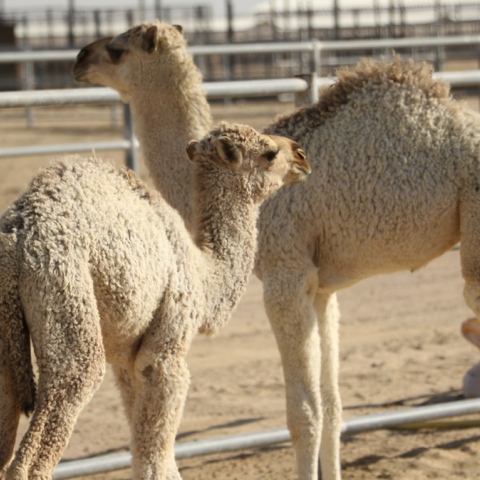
left=263, top=266, right=340, bottom=480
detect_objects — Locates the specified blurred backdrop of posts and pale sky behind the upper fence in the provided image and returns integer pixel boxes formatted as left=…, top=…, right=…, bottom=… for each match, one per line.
left=0, top=0, right=480, bottom=90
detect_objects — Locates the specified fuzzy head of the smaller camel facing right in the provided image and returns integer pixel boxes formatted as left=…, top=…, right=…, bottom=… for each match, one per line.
left=187, top=122, right=311, bottom=202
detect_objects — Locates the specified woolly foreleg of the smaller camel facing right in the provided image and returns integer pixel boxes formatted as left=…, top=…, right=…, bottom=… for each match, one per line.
left=132, top=320, right=193, bottom=480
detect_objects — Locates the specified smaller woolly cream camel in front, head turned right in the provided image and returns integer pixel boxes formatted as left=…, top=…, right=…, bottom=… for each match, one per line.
left=0, top=124, right=310, bottom=480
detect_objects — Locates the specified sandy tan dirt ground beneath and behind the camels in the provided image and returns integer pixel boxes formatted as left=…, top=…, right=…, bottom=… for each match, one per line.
left=0, top=88, right=480, bottom=480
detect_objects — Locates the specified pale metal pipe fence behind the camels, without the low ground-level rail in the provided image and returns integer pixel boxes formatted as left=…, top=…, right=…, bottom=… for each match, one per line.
left=0, top=35, right=480, bottom=171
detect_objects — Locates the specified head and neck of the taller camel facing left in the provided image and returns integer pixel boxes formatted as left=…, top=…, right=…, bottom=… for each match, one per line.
left=73, top=22, right=213, bottom=231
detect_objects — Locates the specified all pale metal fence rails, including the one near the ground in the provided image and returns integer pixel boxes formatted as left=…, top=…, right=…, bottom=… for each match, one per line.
left=0, top=36, right=480, bottom=479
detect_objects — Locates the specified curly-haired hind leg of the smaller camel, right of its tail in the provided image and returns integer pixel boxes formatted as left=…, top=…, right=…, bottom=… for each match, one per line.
left=6, top=270, right=105, bottom=480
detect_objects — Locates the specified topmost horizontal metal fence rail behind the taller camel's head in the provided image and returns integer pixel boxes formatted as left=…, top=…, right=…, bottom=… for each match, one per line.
left=0, top=35, right=480, bottom=63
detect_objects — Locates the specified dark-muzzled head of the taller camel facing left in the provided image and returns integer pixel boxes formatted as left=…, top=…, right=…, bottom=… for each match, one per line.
left=73, top=20, right=186, bottom=103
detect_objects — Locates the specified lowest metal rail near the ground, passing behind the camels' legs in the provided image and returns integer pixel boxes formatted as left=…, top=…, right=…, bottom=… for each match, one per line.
left=53, top=399, right=480, bottom=480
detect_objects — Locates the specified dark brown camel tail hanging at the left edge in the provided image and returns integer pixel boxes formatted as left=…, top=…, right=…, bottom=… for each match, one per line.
left=0, top=233, right=36, bottom=416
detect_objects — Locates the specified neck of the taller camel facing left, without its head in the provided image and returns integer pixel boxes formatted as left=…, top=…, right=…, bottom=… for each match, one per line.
left=130, top=67, right=212, bottom=229
